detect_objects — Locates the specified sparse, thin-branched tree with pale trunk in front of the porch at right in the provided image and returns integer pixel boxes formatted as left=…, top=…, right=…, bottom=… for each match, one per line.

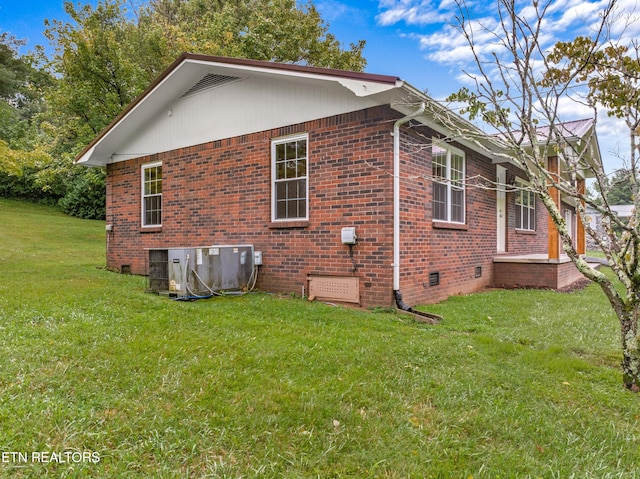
left=443, top=0, right=640, bottom=392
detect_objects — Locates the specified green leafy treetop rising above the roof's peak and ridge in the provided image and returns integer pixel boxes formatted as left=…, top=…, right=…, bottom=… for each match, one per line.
left=143, top=0, right=365, bottom=71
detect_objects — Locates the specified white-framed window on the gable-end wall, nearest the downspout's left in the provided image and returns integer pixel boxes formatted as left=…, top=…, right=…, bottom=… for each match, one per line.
left=271, top=135, right=309, bottom=221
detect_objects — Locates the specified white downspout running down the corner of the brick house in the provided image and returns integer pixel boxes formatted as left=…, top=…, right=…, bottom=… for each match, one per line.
left=392, top=102, right=425, bottom=311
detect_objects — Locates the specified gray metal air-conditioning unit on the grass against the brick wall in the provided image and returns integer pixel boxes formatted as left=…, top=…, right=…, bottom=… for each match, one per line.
left=148, top=245, right=254, bottom=298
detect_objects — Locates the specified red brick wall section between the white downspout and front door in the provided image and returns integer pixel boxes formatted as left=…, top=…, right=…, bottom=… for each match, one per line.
left=400, top=128, right=496, bottom=305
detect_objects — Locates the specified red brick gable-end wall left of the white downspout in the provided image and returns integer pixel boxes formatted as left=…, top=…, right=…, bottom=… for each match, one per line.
left=107, top=107, right=397, bottom=306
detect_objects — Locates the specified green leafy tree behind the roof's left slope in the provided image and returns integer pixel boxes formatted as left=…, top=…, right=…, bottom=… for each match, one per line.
left=45, top=0, right=150, bottom=154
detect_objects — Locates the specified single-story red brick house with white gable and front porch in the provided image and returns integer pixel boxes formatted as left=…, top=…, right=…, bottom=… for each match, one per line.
left=77, top=54, right=599, bottom=306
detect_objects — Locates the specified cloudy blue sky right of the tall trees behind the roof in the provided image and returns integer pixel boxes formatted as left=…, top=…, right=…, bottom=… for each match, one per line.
left=315, top=0, right=640, bottom=172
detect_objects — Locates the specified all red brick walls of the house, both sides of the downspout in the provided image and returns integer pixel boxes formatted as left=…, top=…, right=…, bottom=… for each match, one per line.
left=107, top=107, right=546, bottom=306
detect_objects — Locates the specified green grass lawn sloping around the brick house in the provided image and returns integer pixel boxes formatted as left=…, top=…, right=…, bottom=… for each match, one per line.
left=0, top=200, right=640, bottom=478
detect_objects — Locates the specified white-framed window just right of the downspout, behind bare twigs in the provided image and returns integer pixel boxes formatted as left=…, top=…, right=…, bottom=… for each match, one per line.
left=431, top=142, right=465, bottom=223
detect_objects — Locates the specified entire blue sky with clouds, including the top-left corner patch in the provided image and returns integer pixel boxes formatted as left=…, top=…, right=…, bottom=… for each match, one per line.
left=0, top=0, right=640, bottom=170
